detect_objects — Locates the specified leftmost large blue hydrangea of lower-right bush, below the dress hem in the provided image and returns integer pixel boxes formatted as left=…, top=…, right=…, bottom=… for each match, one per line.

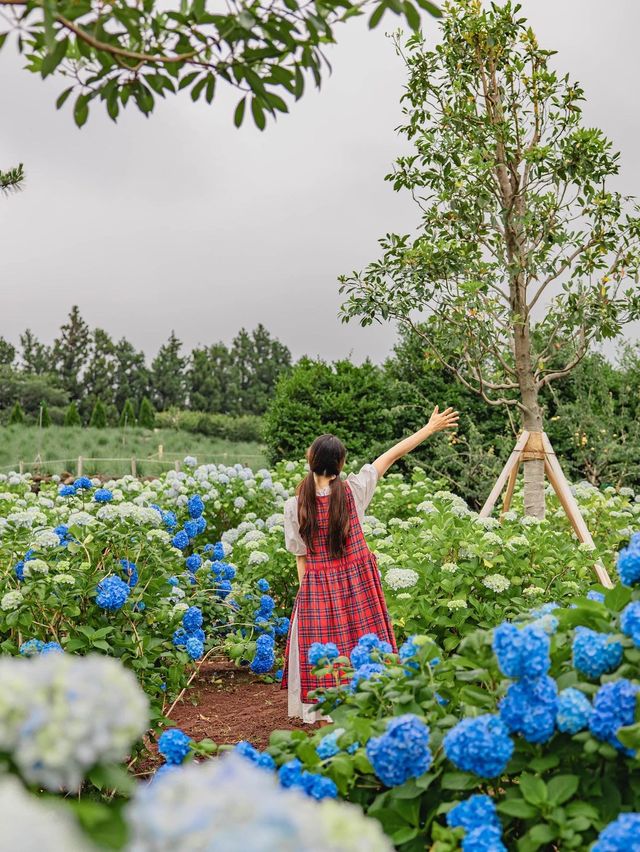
left=366, top=713, right=432, bottom=787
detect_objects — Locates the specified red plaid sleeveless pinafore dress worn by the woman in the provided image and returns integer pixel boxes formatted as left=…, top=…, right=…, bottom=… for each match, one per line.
left=282, top=484, right=397, bottom=702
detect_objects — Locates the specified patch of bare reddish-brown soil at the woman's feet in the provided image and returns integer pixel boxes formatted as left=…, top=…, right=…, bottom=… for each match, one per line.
left=171, top=661, right=318, bottom=748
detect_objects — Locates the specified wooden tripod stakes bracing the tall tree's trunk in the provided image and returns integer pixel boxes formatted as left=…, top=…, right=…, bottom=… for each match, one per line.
left=480, top=431, right=613, bottom=589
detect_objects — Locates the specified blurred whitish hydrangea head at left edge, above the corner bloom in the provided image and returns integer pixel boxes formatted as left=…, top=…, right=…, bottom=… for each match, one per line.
left=0, top=654, right=149, bottom=792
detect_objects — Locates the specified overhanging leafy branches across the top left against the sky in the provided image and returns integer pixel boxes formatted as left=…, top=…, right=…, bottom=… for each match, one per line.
left=0, top=0, right=440, bottom=129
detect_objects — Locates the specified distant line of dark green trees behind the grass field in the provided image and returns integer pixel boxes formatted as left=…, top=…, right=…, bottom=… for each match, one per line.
left=0, top=306, right=291, bottom=426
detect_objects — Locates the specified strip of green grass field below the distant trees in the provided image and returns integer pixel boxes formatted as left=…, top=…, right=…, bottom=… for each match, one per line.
left=0, top=426, right=266, bottom=476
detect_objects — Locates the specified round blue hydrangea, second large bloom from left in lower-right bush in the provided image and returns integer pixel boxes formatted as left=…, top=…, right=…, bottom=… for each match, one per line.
left=443, top=713, right=514, bottom=778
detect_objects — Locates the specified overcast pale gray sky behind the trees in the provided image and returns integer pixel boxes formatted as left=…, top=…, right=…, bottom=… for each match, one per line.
left=0, top=0, right=640, bottom=361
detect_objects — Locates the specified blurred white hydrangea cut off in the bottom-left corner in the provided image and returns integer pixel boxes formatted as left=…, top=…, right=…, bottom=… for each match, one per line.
left=0, top=775, right=95, bottom=852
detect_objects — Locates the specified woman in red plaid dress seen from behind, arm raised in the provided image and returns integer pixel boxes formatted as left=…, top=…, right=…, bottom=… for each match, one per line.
left=282, top=406, right=458, bottom=722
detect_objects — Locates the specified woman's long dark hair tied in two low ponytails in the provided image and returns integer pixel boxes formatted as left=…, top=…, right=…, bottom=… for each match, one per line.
left=297, top=435, right=349, bottom=559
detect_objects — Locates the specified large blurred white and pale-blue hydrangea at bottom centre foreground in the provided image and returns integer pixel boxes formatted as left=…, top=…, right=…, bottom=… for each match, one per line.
left=126, top=754, right=393, bottom=852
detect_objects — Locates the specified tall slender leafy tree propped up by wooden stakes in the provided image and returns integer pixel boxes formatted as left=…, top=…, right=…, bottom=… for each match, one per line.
left=341, top=0, right=640, bottom=517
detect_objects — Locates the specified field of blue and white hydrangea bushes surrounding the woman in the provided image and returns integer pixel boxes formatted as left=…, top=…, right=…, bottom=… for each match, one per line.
left=0, top=459, right=640, bottom=852
